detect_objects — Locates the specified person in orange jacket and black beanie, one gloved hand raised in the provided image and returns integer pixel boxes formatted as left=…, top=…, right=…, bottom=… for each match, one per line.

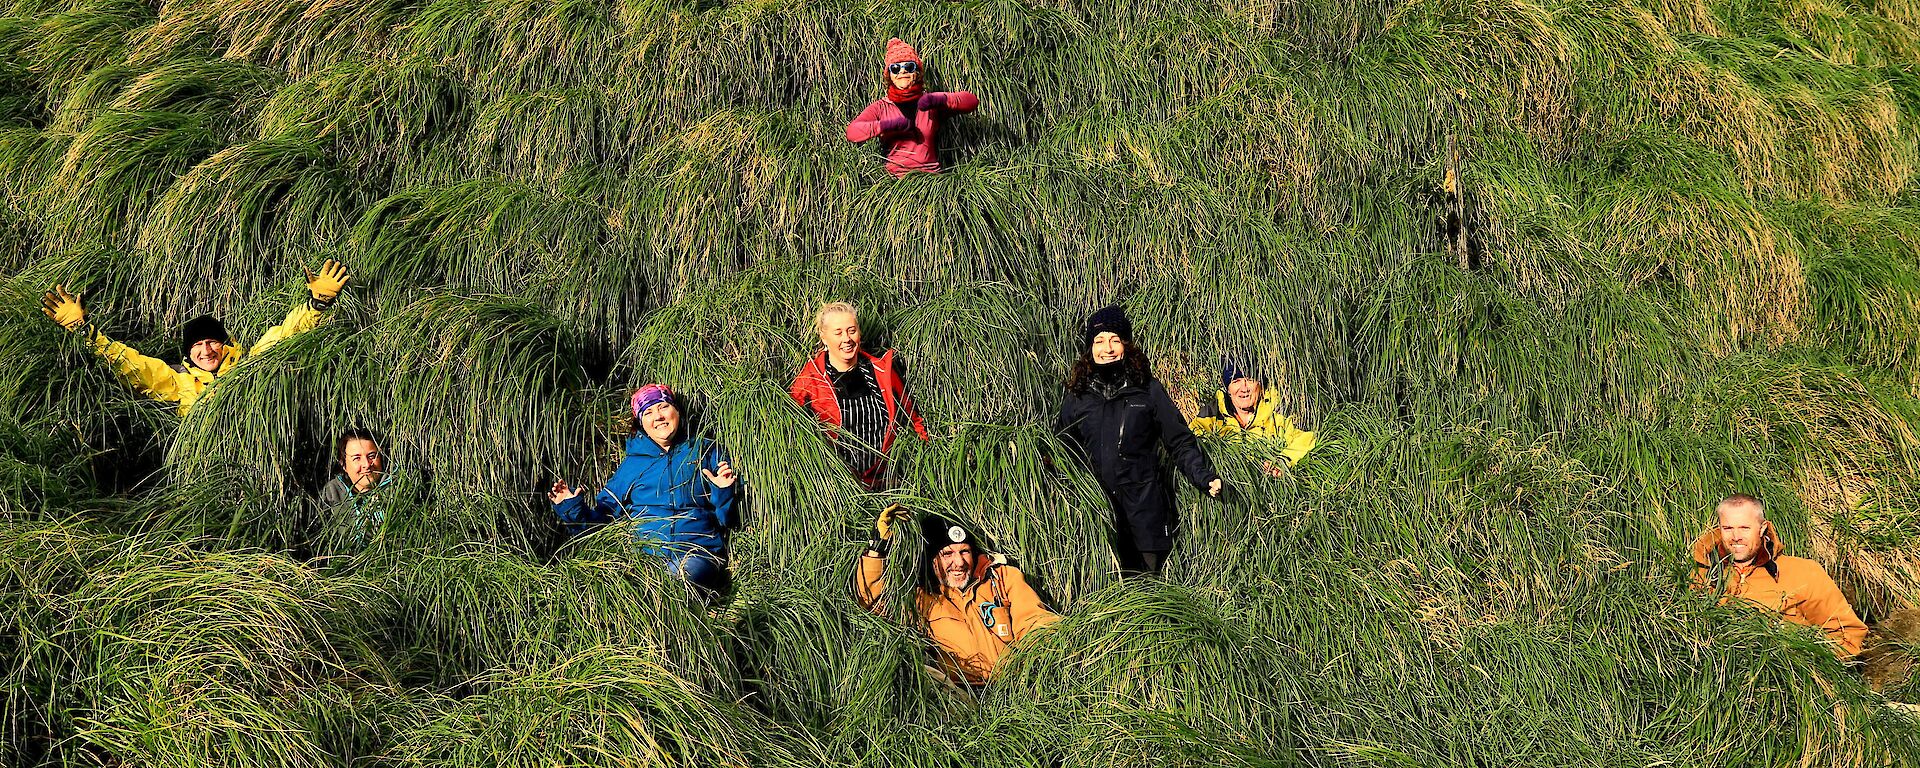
left=856, top=505, right=1060, bottom=687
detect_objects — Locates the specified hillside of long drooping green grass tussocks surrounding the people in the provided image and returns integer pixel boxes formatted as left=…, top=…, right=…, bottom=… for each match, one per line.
left=0, top=0, right=1920, bottom=768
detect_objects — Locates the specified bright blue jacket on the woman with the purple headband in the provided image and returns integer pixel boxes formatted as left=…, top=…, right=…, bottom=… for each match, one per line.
left=553, top=434, right=739, bottom=557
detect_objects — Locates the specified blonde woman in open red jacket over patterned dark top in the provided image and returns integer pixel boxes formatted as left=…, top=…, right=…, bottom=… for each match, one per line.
left=789, top=301, right=927, bottom=490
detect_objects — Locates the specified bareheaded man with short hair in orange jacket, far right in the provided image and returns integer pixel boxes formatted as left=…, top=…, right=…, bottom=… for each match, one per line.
left=1693, top=493, right=1866, bottom=659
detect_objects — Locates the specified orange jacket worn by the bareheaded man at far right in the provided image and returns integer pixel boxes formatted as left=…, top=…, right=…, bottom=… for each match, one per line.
left=1693, top=520, right=1866, bottom=659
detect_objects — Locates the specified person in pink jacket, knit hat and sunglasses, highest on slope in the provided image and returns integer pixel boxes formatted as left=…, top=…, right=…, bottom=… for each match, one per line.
left=847, top=38, right=979, bottom=177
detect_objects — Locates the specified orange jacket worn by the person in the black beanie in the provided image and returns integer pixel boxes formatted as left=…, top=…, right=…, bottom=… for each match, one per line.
left=858, top=555, right=1060, bottom=685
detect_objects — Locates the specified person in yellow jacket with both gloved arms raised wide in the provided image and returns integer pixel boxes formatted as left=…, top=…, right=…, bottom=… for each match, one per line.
left=40, top=259, right=353, bottom=413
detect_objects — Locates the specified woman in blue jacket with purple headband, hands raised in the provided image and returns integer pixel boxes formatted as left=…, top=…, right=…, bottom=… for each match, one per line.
left=547, top=384, right=739, bottom=597
